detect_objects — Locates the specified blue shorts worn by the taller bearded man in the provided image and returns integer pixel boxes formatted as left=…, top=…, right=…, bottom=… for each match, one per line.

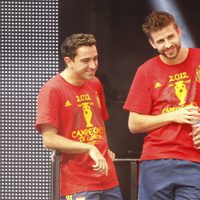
left=139, top=159, right=200, bottom=200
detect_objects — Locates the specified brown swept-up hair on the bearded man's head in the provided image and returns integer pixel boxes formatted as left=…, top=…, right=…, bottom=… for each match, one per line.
left=142, top=11, right=178, bottom=38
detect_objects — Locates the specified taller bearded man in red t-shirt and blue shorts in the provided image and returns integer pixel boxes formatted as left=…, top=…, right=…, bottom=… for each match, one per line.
left=124, top=11, right=200, bottom=200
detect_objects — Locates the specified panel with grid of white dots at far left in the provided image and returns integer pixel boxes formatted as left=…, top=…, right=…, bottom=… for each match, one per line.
left=0, top=0, right=58, bottom=200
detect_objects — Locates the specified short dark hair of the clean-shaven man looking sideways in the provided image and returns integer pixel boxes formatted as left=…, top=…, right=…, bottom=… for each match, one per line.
left=61, top=33, right=96, bottom=60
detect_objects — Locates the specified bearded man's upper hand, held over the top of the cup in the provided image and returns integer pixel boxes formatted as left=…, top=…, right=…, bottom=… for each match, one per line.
left=169, top=106, right=200, bottom=124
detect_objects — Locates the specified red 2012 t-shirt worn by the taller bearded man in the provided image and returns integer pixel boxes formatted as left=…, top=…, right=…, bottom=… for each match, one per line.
left=123, top=49, right=200, bottom=162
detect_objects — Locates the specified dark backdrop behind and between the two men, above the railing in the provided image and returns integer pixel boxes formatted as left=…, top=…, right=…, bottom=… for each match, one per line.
left=59, top=0, right=200, bottom=158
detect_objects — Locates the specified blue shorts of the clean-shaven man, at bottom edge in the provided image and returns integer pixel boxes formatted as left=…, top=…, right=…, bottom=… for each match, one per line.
left=60, top=186, right=123, bottom=200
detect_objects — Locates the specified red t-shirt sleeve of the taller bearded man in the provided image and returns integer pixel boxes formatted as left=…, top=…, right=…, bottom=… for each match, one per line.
left=123, top=68, right=152, bottom=114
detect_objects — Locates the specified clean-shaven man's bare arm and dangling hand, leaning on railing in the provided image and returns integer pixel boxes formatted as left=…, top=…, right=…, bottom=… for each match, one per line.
left=41, top=124, right=108, bottom=175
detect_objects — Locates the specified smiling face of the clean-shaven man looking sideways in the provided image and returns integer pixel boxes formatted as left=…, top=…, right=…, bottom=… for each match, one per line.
left=68, top=45, right=98, bottom=81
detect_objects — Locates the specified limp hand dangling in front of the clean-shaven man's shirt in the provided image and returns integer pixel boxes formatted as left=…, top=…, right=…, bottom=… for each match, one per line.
left=89, top=146, right=108, bottom=176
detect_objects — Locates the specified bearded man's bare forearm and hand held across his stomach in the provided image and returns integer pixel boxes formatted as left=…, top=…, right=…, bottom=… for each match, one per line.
left=128, top=106, right=200, bottom=133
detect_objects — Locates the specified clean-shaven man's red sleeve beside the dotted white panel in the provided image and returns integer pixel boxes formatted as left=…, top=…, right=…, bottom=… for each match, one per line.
left=35, top=85, right=59, bottom=132
